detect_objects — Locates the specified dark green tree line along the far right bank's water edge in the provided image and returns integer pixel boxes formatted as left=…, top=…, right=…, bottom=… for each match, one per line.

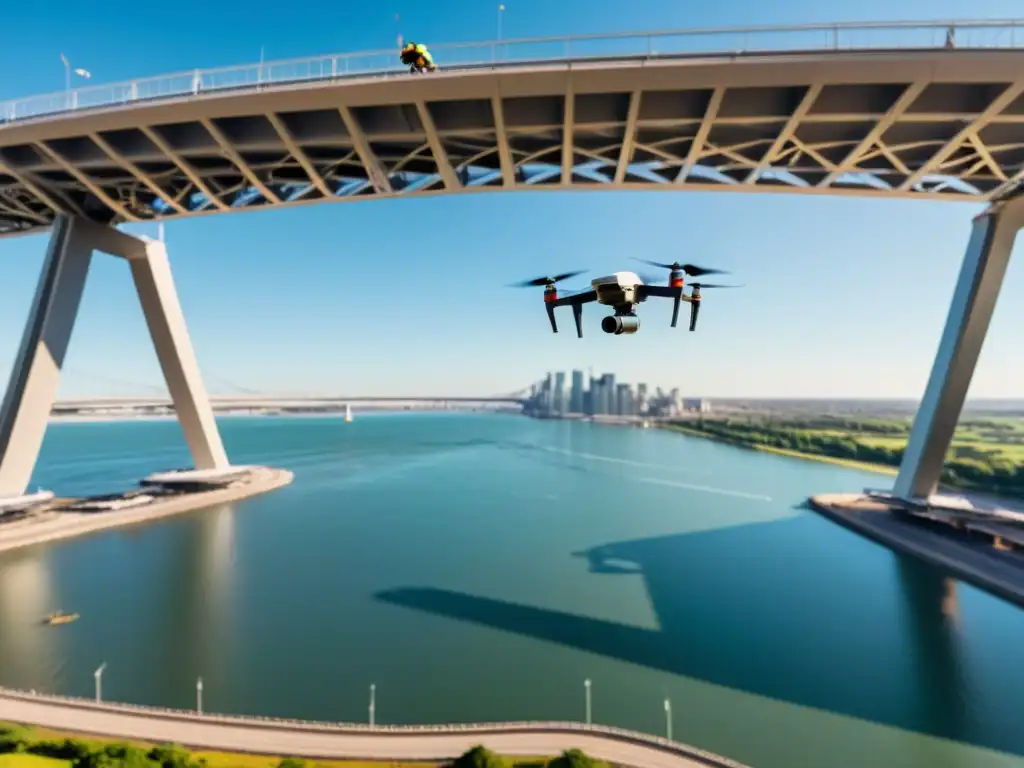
left=677, top=419, right=1024, bottom=497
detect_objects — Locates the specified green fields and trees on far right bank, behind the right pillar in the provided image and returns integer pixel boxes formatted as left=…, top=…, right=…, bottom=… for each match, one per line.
left=669, top=416, right=1024, bottom=498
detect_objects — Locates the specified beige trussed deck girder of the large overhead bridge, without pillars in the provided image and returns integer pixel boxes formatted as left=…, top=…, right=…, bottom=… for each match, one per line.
left=0, top=50, right=1024, bottom=236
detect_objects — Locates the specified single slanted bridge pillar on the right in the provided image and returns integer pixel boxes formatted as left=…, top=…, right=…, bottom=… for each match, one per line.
left=893, top=198, right=1024, bottom=500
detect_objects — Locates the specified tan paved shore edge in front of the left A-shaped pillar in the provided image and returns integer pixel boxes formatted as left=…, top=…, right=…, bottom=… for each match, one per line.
left=0, top=467, right=295, bottom=553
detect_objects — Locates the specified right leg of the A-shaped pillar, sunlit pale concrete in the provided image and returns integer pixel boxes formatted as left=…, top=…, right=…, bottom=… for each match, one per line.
left=129, top=241, right=230, bottom=469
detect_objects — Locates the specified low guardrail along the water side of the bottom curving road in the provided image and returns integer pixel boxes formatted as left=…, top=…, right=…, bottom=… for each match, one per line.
left=0, top=688, right=745, bottom=768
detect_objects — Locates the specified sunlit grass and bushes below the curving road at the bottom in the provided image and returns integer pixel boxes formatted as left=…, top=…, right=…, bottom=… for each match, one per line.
left=0, top=723, right=608, bottom=768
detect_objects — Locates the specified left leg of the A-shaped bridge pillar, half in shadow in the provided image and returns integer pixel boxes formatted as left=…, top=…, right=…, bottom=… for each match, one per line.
left=0, top=216, right=92, bottom=499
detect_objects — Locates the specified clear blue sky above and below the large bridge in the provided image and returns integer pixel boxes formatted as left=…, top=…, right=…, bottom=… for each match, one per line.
left=0, top=0, right=1024, bottom=397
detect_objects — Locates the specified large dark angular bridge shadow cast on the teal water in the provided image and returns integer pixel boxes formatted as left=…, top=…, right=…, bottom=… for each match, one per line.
left=376, top=516, right=1024, bottom=754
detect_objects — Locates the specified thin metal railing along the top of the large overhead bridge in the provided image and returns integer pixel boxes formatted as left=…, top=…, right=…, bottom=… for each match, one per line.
left=0, top=19, right=1024, bottom=124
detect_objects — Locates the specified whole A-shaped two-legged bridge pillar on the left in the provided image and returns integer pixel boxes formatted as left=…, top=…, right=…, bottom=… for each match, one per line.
left=0, top=215, right=229, bottom=498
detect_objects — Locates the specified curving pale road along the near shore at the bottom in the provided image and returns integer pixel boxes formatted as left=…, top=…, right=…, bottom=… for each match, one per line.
left=0, top=691, right=744, bottom=768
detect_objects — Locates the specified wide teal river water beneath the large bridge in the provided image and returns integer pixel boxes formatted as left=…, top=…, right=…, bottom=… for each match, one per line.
left=0, top=414, right=1024, bottom=768
